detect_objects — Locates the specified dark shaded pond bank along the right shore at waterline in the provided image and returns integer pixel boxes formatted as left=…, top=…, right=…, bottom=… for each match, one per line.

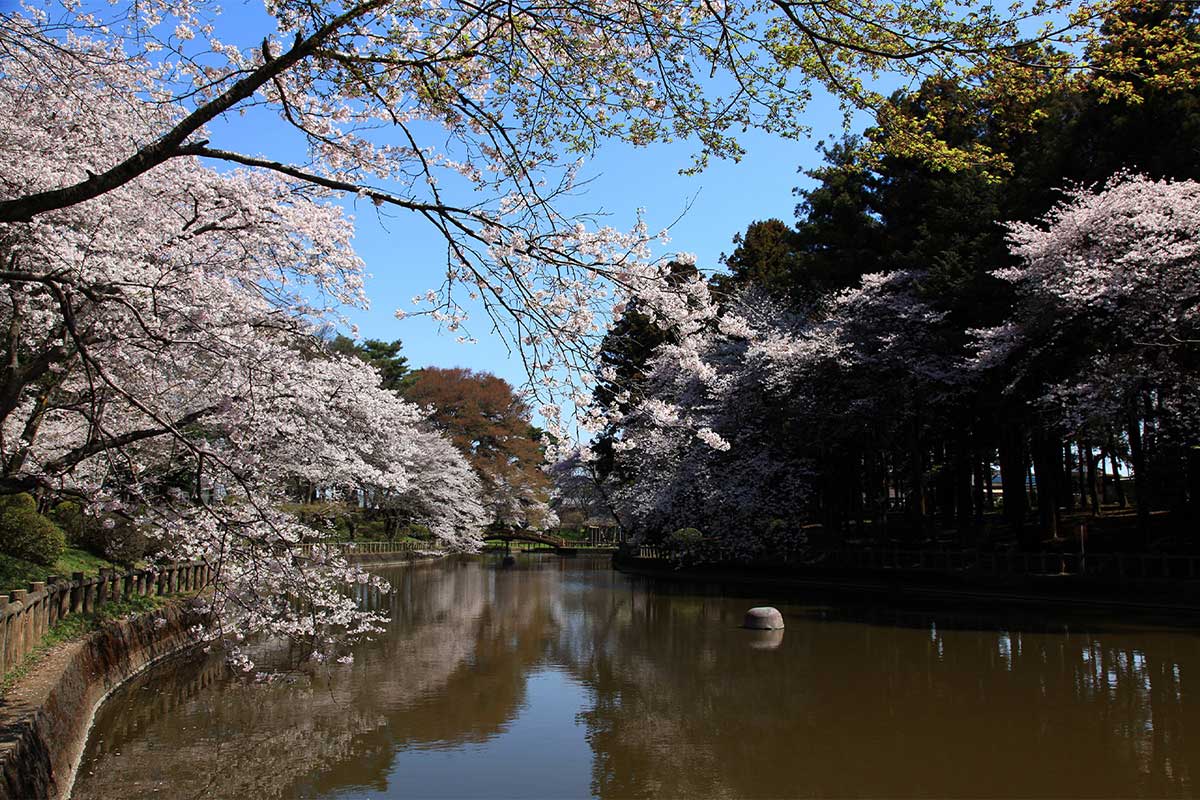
left=613, top=552, right=1200, bottom=616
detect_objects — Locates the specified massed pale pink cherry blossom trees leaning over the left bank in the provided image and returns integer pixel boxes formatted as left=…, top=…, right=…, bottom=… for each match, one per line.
left=0, top=41, right=482, bottom=667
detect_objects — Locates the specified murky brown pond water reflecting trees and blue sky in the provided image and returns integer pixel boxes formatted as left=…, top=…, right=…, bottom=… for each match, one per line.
left=74, top=555, right=1200, bottom=800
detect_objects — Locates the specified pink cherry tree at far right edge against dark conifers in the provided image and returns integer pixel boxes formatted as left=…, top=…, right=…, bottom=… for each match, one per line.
left=977, top=174, right=1200, bottom=535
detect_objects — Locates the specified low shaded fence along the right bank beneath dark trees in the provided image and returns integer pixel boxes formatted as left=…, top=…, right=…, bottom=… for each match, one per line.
left=637, top=547, right=1200, bottom=582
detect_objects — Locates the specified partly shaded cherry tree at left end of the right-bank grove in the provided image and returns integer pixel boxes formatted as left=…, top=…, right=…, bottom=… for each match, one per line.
left=600, top=271, right=970, bottom=560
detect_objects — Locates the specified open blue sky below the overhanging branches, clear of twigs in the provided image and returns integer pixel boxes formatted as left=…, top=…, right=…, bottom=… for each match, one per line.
left=326, top=105, right=841, bottom=393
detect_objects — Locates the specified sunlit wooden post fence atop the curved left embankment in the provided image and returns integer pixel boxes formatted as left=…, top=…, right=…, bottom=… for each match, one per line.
left=0, top=561, right=212, bottom=675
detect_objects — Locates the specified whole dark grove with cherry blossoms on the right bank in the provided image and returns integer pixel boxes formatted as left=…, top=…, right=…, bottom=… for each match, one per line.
left=598, top=2, right=1200, bottom=558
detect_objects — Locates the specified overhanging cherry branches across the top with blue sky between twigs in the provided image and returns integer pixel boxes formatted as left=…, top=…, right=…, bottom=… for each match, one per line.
left=0, top=0, right=1152, bottom=438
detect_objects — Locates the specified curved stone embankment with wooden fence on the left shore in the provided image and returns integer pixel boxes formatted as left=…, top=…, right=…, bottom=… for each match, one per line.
left=0, top=563, right=211, bottom=800
